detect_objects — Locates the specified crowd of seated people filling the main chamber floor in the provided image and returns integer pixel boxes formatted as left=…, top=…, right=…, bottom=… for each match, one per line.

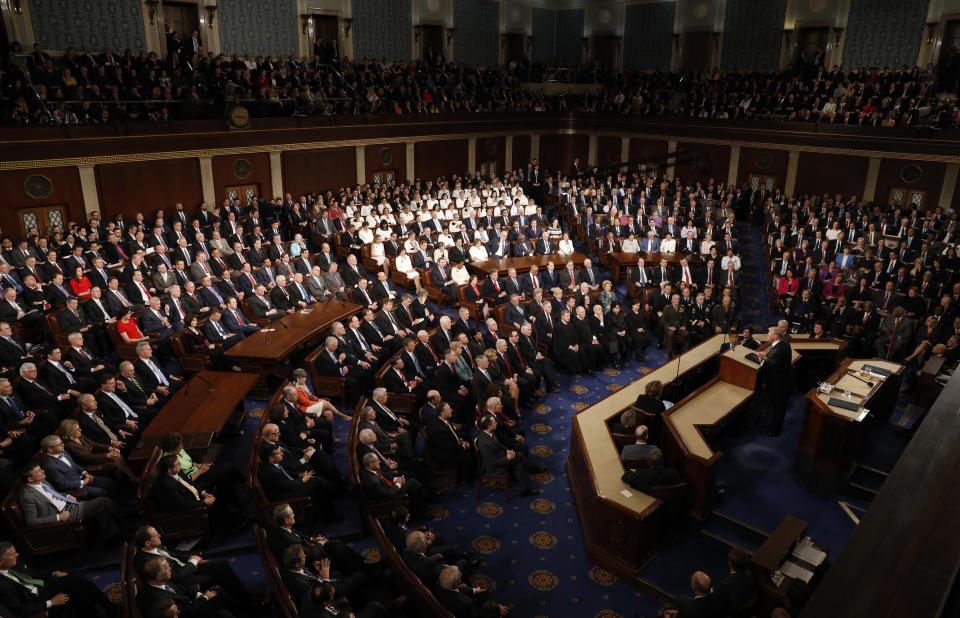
left=0, top=147, right=960, bottom=612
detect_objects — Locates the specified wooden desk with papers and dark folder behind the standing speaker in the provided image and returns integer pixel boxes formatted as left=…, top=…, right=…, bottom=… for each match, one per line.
left=796, top=358, right=903, bottom=493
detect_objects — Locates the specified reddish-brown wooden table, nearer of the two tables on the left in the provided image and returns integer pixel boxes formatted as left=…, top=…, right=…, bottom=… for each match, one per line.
left=129, top=371, right=257, bottom=461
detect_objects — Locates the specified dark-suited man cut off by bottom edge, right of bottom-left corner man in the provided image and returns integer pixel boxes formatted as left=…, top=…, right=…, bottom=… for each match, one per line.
left=137, top=556, right=235, bottom=618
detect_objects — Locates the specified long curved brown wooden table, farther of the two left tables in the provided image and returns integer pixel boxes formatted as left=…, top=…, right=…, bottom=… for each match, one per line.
left=223, top=300, right=361, bottom=397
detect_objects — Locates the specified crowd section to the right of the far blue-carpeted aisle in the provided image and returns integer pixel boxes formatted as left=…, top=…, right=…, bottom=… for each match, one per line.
left=764, top=195, right=960, bottom=390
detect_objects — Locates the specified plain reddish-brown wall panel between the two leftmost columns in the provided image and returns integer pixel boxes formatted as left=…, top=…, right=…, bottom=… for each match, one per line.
left=96, top=159, right=203, bottom=220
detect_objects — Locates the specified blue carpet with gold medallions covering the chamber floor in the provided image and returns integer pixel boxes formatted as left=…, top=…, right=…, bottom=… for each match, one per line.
left=75, top=228, right=906, bottom=618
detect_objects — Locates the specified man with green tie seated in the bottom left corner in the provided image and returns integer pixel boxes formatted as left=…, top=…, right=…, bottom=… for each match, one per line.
left=0, top=541, right=122, bottom=617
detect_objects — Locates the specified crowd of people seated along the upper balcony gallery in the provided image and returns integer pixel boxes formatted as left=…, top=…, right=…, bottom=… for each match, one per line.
left=7, top=32, right=960, bottom=128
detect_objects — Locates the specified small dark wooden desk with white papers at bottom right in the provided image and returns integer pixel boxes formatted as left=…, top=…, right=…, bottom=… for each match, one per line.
left=751, top=515, right=830, bottom=616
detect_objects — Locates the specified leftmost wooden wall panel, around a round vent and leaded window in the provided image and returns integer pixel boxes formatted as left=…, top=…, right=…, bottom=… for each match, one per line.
left=0, top=167, right=86, bottom=243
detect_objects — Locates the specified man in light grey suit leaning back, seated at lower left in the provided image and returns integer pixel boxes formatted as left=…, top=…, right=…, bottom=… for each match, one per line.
left=20, top=461, right=120, bottom=541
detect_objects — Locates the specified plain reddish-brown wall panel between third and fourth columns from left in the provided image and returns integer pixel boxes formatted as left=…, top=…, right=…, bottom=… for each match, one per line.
left=281, top=148, right=360, bottom=196
